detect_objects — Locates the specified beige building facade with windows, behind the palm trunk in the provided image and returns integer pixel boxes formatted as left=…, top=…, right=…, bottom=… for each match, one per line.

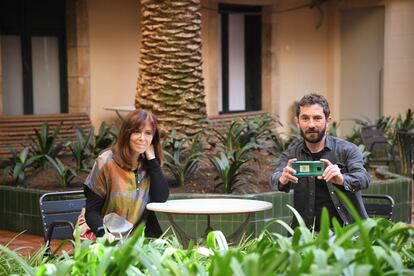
left=0, top=0, right=414, bottom=133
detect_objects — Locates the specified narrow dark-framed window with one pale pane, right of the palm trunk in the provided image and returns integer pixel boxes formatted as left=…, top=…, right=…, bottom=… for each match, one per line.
left=219, top=4, right=262, bottom=114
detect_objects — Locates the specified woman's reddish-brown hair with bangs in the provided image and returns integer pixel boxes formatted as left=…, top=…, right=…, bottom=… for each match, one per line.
left=114, top=109, right=164, bottom=169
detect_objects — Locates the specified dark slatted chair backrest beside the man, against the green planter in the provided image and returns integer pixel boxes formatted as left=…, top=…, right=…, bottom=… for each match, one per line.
left=362, top=194, right=395, bottom=219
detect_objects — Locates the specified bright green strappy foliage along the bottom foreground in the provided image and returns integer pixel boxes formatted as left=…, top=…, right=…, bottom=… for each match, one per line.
left=0, top=194, right=414, bottom=276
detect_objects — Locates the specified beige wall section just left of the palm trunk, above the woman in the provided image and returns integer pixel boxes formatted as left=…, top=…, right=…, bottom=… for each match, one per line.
left=88, top=0, right=141, bottom=127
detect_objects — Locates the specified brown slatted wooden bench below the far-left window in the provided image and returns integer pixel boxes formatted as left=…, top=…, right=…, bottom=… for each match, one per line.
left=0, top=113, right=91, bottom=159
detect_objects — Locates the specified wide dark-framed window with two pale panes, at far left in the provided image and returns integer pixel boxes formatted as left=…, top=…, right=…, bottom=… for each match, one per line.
left=0, top=0, right=68, bottom=115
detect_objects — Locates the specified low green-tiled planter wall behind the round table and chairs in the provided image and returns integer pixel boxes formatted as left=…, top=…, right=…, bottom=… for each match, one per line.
left=0, top=169, right=412, bottom=237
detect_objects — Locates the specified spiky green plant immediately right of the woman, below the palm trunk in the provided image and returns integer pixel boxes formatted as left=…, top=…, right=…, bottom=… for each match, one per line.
left=163, top=130, right=203, bottom=186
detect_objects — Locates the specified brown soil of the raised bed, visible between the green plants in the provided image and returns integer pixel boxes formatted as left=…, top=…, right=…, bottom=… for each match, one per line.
left=0, top=152, right=381, bottom=194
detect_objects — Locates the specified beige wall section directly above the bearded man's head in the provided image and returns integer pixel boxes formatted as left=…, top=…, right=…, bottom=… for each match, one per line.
left=272, top=4, right=328, bottom=129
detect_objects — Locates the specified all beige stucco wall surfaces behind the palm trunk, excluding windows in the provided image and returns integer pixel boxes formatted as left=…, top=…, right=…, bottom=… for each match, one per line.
left=82, top=0, right=414, bottom=134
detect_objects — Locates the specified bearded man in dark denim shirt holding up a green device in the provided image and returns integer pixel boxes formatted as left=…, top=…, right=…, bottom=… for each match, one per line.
left=271, top=93, right=370, bottom=231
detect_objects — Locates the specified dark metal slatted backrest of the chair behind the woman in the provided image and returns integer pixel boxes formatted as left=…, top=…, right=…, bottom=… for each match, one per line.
left=39, top=190, right=85, bottom=241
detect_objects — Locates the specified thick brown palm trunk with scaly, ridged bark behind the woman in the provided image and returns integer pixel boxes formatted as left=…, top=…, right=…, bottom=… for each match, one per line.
left=135, top=0, right=206, bottom=135
